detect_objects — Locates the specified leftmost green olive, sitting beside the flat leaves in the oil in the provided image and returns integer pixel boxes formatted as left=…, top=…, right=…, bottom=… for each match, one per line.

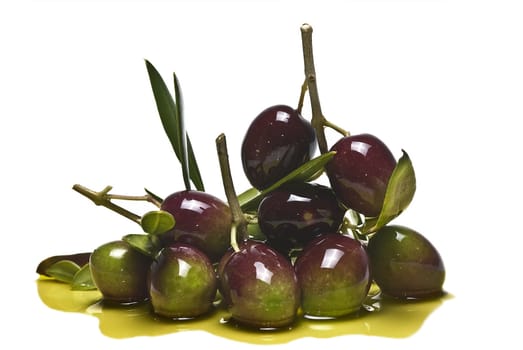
left=89, top=240, right=152, bottom=303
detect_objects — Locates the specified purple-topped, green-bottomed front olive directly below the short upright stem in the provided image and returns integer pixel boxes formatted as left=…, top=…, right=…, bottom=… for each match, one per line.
left=220, top=240, right=300, bottom=329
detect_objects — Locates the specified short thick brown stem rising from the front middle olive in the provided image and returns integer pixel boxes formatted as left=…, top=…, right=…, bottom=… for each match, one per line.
left=216, top=133, right=248, bottom=252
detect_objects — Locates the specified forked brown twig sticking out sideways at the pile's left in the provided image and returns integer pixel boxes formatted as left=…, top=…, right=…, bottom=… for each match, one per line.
left=73, top=184, right=158, bottom=225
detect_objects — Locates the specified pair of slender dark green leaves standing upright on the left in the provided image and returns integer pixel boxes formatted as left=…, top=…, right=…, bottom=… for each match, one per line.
left=145, top=60, right=205, bottom=191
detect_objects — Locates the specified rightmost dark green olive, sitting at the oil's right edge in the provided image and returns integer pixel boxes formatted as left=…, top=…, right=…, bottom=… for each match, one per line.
left=367, top=225, right=445, bottom=299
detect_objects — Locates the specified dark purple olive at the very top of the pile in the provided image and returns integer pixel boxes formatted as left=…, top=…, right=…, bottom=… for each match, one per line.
left=241, top=105, right=316, bottom=190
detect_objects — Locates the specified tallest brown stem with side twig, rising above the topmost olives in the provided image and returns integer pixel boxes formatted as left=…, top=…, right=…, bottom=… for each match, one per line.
left=301, top=23, right=349, bottom=154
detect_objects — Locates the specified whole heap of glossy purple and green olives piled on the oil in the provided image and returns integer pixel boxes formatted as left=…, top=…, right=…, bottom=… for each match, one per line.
left=35, top=24, right=445, bottom=329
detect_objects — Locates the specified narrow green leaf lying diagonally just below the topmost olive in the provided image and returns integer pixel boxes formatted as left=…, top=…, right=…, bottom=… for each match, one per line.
left=238, top=151, right=336, bottom=212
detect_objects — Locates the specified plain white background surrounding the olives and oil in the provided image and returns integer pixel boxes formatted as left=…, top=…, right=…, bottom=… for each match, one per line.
left=0, top=1, right=523, bottom=349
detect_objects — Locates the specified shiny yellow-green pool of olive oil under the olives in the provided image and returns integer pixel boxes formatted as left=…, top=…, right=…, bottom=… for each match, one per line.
left=36, top=278, right=451, bottom=344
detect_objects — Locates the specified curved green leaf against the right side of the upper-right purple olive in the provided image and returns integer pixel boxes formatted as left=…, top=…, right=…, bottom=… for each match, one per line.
left=366, top=150, right=416, bottom=233
